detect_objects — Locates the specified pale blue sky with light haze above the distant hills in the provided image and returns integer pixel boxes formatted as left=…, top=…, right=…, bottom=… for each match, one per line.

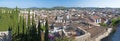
left=0, top=0, right=120, bottom=8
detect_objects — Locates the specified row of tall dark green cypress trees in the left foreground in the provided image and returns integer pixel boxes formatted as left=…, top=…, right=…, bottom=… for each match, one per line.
left=10, top=8, right=49, bottom=41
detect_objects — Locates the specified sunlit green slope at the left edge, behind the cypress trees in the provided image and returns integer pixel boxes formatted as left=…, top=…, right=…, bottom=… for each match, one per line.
left=0, top=10, right=17, bottom=31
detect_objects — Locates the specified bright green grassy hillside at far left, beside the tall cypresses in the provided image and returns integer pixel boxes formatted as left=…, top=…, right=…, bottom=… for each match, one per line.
left=0, top=9, right=18, bottom=31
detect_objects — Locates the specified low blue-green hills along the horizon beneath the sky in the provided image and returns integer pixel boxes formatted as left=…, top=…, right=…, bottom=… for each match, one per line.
left=0, top=6, right=118, bottom=10
